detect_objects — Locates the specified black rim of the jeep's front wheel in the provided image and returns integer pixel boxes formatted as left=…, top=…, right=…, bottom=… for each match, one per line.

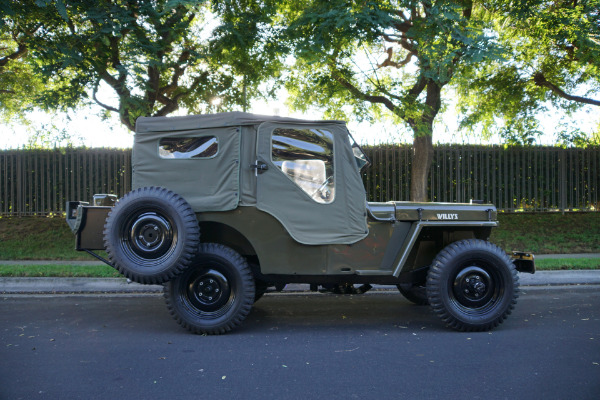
left=449, top=261, right=504, bottom=315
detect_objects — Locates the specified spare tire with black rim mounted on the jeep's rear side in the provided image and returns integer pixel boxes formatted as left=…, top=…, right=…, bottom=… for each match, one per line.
left=104, top=187, right=200, bottom=284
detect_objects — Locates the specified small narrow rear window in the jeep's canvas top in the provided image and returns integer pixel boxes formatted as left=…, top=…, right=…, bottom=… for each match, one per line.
left=158, top=136, right=219, bottom=159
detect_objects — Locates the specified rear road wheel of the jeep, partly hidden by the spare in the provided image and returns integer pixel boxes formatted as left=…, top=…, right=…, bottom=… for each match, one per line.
left=164, top=243, right=255, bottom=335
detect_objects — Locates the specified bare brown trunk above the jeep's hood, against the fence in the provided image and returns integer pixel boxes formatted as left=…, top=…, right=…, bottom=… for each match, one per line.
left=410, top=134, right=433, bottom=202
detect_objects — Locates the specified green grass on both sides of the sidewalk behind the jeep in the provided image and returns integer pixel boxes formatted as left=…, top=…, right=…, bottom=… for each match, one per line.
left=0, top=212, right=600, bottom=277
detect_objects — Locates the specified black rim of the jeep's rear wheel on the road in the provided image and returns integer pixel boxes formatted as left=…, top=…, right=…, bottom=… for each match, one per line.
left=178, top=263, right=236, bottom=319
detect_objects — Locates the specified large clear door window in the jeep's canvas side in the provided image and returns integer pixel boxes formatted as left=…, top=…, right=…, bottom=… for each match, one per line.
left=271, top=128, right=335, bottom=203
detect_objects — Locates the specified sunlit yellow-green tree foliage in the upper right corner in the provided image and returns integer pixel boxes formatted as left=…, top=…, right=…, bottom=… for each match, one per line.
left=456, top=0, right=600, bottom=143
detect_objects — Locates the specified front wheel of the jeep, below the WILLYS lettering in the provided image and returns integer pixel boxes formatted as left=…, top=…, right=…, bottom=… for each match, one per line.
left=427, top=239, right=518, bottom=331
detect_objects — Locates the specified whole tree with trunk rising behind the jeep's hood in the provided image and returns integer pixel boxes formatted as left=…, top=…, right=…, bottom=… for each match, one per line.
left=284, top=0, right=499, bottom=201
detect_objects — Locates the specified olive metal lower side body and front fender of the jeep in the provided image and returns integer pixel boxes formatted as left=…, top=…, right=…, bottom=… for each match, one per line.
left=197, top=203, right=497, bottom=284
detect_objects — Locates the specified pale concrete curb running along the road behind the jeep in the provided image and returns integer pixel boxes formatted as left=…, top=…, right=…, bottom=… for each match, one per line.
left=0, top=270, right=600, bottom=294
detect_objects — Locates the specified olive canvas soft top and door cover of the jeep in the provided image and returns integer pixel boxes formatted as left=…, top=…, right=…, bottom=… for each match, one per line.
left=132, top=112, right=368, bottom=245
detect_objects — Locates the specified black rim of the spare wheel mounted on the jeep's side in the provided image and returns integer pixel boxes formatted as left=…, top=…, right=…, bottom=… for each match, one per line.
left=120, top=210, right=177, bottom=261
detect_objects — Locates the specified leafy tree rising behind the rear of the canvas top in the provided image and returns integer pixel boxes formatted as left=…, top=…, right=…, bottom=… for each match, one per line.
left=1, top=0, right=278, bottom=130
